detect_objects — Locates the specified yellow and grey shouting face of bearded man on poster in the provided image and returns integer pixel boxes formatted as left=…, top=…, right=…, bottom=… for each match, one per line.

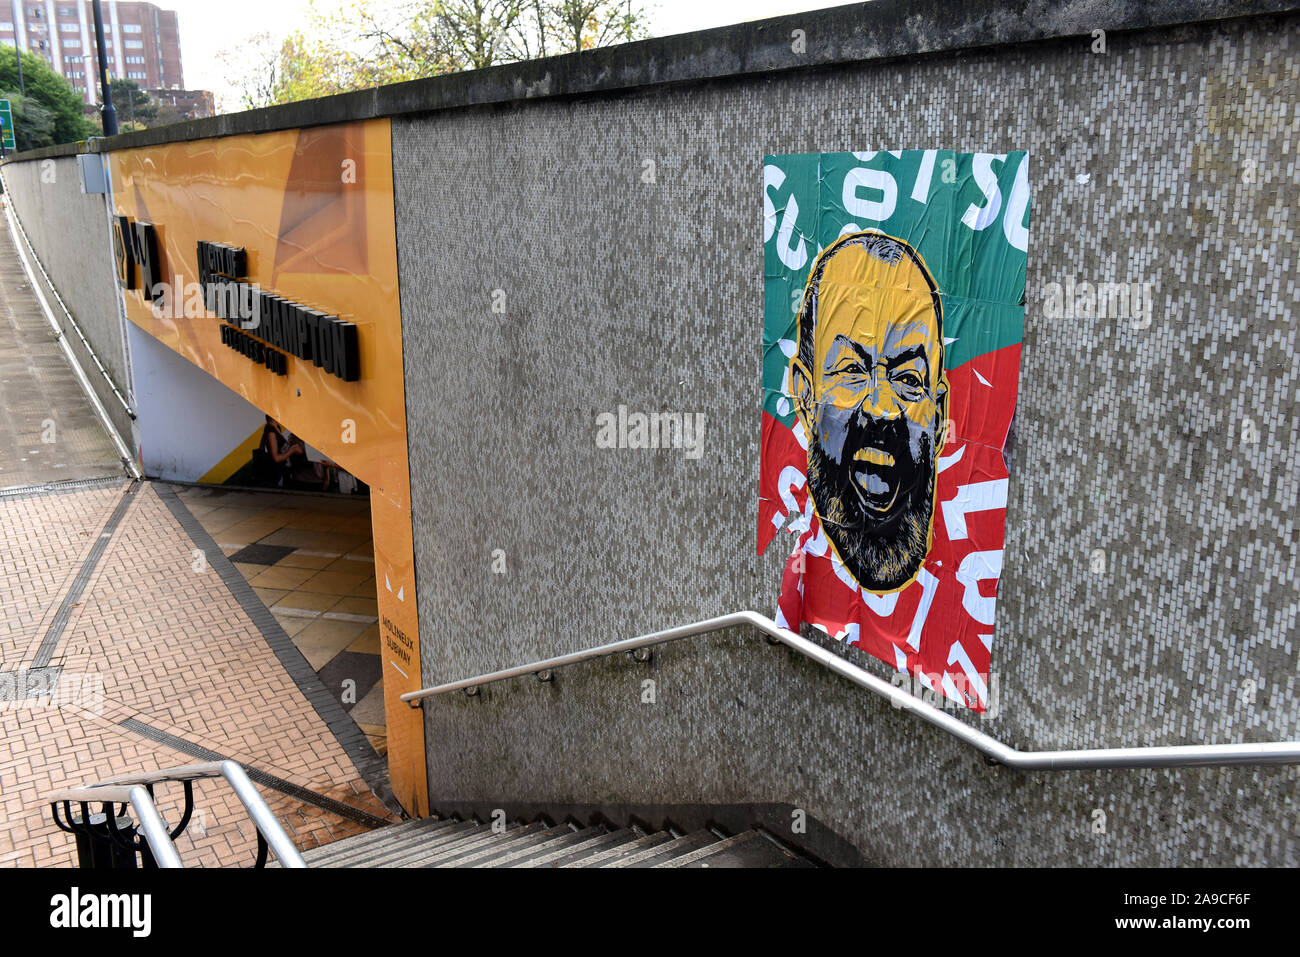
left=792, top=236, right=948, bottom=594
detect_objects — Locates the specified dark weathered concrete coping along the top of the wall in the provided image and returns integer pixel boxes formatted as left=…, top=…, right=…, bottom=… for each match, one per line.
left=7, top=0, right=1300, bottom=163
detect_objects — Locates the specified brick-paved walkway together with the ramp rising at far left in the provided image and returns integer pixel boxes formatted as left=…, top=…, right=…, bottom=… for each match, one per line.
left=0, top=213, right=398, bottom=866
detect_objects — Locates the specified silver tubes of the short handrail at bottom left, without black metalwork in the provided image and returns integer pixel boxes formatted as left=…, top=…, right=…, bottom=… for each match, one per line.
left=46, top=761, right=307, bottom=867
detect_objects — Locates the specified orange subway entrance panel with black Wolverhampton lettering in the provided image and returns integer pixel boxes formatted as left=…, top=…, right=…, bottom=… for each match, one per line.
left=109, top=113, right=428, bottom=815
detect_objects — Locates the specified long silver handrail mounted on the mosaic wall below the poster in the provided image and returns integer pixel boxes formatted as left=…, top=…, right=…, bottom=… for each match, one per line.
left=402, top=611, right=1300, bottom=771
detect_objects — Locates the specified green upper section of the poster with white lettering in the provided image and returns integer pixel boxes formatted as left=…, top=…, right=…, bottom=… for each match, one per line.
left=763, top=150, right=1030, bottom=426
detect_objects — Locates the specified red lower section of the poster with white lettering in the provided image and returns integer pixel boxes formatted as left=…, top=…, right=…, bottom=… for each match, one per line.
left=758, top=345, right=1021, bottom=711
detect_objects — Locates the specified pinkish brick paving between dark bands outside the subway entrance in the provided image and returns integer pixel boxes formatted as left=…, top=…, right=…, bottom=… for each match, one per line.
left=0, top=482, right=397, bottom=866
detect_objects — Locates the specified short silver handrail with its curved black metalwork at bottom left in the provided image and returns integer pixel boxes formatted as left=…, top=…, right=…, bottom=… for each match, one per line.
left=46, top=761, right=307, bottom=867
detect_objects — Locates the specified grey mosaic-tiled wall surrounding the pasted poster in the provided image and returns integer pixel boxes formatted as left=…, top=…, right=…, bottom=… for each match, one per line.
left=7, top=0, right=1300, bottom=866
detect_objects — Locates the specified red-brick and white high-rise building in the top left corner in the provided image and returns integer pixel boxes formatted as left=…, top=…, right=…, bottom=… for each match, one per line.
left=0, top=0, right=185, bottom=105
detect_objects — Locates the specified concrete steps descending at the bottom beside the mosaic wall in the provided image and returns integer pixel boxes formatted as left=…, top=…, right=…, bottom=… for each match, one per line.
left=287, top=818, right=814, bottom=867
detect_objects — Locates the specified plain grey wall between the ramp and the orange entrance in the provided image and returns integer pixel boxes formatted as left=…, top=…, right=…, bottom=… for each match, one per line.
left=4, top=156, right=133, bottom=447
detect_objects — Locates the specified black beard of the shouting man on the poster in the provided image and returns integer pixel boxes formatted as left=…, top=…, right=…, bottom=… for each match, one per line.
left=809, top=424, right=935, bottom=592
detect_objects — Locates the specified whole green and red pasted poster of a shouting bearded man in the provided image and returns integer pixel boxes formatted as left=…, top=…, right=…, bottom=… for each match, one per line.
left=758, top=150, right=1030, bottom=711
